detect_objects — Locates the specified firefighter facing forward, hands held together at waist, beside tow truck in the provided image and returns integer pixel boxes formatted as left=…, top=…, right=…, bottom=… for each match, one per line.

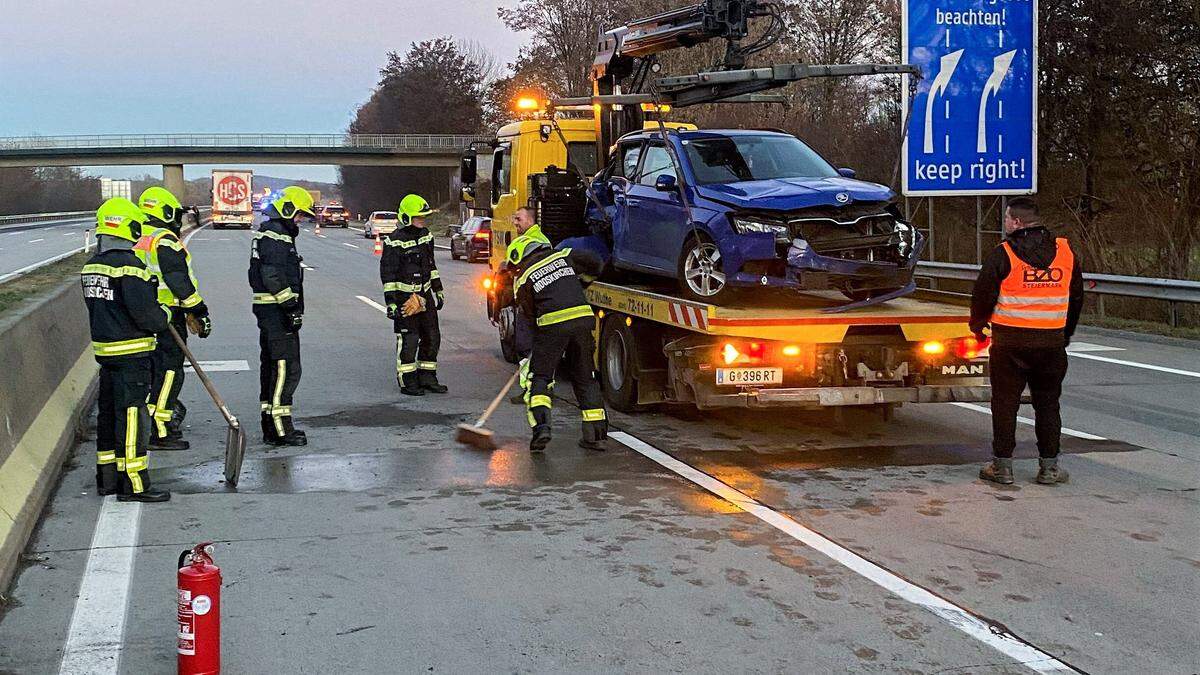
left=379, top=195, right=449, bottom=396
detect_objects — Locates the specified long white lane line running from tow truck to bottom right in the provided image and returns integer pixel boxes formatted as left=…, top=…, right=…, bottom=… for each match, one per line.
left=608, top=431, right=1079, bottom=673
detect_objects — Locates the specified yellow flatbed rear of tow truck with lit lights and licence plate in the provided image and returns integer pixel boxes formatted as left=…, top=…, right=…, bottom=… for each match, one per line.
left=588, top=282, right=991, bottom=414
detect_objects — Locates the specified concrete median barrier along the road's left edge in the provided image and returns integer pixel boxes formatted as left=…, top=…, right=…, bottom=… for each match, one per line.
left=0, top=275, right=98, bottom=592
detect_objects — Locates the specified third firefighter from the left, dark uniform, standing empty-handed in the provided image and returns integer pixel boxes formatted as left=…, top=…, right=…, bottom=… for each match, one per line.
left=250, top=185, right=313, bottom=446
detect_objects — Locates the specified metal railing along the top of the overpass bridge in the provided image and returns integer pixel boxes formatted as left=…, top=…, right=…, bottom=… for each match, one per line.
left=0, top=133, right=487, bottom=153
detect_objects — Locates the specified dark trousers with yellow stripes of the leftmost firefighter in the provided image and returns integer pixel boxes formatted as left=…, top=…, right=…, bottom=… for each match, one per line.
left=96, top=353, right=154, bottom=494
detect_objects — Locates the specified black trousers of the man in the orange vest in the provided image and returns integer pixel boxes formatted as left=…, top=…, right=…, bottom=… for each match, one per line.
left=991, top=344, right=1067, bottom=459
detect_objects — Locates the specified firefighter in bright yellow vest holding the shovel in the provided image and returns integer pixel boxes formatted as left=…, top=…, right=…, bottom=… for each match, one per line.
left=133, top=186, right=212, bottom=450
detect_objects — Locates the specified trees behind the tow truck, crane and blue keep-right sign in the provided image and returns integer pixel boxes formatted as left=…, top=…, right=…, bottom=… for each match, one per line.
left=342, top=0, right=1200, bottom=285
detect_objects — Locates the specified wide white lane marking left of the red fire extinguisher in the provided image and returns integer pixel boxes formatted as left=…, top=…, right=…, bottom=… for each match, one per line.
left=59, top=496, right=142, bottom=675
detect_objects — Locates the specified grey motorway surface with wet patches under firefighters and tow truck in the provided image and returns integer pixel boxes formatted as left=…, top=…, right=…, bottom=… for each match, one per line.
left=0, top=219, right=1200, bottom=674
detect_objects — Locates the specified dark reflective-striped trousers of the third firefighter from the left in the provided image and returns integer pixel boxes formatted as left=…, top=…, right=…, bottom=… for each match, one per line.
left=254, top=305, right=300, bottom=437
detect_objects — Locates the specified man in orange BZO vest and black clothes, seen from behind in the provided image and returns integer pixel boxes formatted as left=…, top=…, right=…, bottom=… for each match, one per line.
left=971, top=197, right=1084, bottom=485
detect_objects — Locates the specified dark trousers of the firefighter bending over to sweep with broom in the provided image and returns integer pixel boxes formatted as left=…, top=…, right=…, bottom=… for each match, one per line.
left=526, top=318, right=608, bottom=441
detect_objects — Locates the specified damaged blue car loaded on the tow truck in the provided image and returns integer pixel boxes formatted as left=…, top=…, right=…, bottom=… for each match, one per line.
left=593, top=130, right=924, bottom=305
